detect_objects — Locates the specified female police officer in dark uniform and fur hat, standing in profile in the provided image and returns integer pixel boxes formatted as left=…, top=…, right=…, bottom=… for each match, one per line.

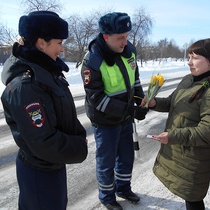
left=1, top=11, right=87, bottom=210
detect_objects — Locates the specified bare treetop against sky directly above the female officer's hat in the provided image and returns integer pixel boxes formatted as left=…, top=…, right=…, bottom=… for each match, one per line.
left=21, top=0, right=63, bottom=14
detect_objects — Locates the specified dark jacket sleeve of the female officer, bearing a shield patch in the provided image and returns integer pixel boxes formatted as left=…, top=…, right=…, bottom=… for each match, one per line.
left=2, top=83, right=87, bottom=163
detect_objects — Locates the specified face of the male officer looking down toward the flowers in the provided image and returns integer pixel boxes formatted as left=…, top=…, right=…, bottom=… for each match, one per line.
left=103, top=32, right=129, bottom=53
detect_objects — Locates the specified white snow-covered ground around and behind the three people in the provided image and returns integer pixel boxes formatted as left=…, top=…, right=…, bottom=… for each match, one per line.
left=0, top=61, right=210, bottom=210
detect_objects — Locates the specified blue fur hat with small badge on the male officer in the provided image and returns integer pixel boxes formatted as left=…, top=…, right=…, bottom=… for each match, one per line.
left=99, top=12, right=132, bottom=34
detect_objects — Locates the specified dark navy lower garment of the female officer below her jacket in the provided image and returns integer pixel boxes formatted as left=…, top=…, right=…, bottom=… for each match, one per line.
left=16, top=158, right=67, bottom=210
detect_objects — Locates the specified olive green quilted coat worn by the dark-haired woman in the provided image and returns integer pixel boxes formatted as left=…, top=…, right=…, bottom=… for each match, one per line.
left=153, top=74, right=210, bottom=202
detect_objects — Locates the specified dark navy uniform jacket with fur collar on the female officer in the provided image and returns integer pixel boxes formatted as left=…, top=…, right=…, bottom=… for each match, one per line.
left=1, top=43, right=87, bottom=170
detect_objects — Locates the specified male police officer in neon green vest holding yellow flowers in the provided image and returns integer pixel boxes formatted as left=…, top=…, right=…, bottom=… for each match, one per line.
left=81, top=12, right=148, bottom=210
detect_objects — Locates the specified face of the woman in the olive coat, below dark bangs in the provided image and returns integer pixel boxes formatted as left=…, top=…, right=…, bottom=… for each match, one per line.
left=188, top=53, right=210, bottom=76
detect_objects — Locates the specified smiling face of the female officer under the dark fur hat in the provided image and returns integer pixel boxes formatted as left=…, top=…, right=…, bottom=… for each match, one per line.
left=37, top=38, right=64, bottom=60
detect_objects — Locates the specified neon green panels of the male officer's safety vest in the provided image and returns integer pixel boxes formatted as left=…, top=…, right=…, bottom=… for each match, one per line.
left=100, top=53, right=136, bottom=96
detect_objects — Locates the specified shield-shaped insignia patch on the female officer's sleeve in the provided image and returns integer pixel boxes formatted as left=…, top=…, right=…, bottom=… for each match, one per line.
left=25, top=102, right=45, bottom=128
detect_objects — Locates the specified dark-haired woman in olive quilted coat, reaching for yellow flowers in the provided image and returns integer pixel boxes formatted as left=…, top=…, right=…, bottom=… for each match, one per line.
left=149, top=39, right=210, bottom=210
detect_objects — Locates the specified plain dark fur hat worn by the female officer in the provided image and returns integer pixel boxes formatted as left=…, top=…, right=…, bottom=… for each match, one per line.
left=19, top=11, right=68, bottom=39
